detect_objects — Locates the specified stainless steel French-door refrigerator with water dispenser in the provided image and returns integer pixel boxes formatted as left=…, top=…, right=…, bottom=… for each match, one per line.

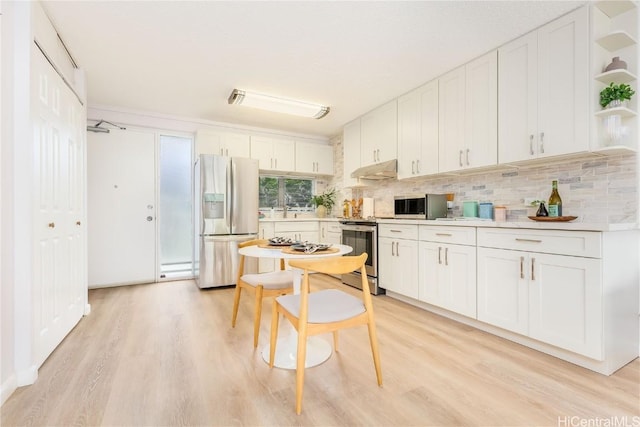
left=194, top=154, right=259, bottom=288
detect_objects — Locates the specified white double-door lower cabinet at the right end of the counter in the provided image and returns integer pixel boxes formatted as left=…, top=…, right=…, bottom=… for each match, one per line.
left=478, top=230, right=603, bottom=360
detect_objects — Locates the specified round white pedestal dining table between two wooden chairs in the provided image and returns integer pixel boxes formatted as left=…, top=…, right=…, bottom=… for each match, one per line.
left=238, top=245, right=353, bottom=369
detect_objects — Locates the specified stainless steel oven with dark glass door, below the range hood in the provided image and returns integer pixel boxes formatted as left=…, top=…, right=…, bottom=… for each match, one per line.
left=340, top=219, right=385, bottom=295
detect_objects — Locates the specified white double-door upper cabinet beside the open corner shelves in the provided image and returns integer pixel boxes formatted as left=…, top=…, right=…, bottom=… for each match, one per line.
left=498, top=7, right=590, bottom=163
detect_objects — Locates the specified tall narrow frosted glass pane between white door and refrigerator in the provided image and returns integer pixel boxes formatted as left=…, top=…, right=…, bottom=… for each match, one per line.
left=158, top=135, right=193, bottom=278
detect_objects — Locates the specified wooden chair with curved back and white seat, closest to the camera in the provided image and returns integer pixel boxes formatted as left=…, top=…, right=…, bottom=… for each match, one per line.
left=269, top=253, right=382, bottom=415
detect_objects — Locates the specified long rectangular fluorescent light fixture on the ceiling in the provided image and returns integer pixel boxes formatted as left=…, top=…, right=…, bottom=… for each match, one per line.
left=229, top=89, right=329, bottom=119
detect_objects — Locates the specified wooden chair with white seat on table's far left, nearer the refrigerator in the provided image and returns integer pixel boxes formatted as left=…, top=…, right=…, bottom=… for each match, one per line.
left=231, top=239, right=293, bottom=348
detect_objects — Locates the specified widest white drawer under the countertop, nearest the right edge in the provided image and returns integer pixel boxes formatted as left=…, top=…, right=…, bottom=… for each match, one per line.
left=478, top=228, right=602, bottom=258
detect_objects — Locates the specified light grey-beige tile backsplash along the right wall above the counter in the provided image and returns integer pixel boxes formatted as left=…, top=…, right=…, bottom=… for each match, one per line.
left=328, top=136, right=638, bottom=224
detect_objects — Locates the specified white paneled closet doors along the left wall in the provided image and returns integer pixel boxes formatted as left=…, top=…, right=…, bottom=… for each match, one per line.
left=31, top=47, right=87, bottom=366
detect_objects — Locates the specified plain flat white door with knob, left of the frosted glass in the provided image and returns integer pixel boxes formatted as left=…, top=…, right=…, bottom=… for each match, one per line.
left=87, top=125, right=157, bottom=288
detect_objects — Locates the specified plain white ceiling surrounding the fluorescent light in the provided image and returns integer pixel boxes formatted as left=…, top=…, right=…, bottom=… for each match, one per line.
left=43, top=1, right=584, bottom=136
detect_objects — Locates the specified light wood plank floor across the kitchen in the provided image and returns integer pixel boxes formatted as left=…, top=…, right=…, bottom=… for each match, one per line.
left=1, top=275, right=640, bottom=427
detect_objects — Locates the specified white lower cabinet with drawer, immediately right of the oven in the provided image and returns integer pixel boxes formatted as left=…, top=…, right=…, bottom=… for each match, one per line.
left=378, top=225, right=419, bottom=299
